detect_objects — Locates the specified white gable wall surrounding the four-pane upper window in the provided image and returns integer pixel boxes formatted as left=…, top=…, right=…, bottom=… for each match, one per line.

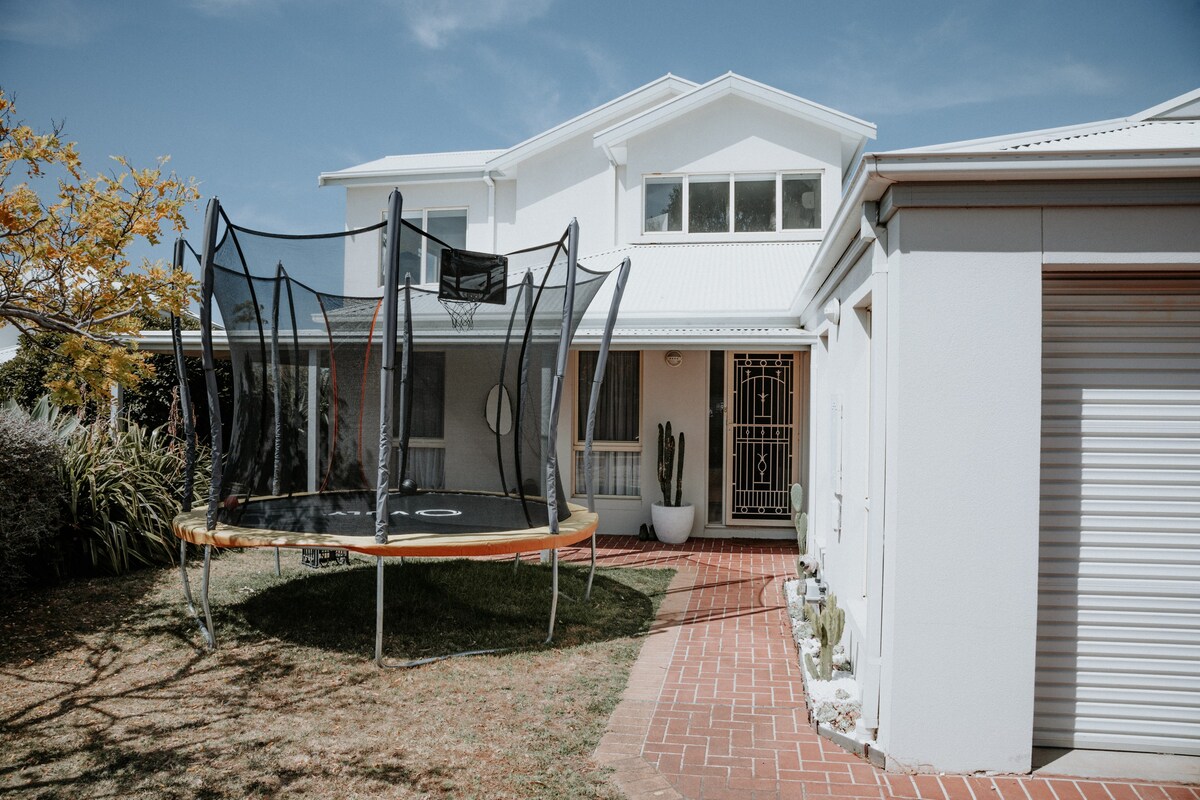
left=618, top=96, right=841, bottom=242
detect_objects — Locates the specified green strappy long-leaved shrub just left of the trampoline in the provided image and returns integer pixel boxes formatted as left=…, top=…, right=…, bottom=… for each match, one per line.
left=62, top=420, right=209, bottom=575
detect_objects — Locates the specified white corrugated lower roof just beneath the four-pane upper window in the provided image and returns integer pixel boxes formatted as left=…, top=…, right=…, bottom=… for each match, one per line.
left=580, top=237, right=820, bottom=330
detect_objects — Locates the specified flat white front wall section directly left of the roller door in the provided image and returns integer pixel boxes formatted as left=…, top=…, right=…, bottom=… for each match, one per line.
left=880, top=210, right=1042, bottom=772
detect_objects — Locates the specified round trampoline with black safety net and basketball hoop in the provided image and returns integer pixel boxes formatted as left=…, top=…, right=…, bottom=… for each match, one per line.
left=172, top=191, right=630, bottom=667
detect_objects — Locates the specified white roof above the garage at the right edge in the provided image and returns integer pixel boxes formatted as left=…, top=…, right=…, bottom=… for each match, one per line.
left=880, top=89, right=1200, bottom=155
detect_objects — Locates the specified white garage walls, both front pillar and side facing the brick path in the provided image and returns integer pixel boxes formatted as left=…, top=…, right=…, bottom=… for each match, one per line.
left=809, top=210, right=1042, bottom=772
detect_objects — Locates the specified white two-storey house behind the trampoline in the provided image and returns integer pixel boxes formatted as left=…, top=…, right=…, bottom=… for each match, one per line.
left=320, top=73, right=875, bottom=536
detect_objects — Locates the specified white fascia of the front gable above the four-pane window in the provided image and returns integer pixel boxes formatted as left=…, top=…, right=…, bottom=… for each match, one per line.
left=592, top=72, right=876, bottom=163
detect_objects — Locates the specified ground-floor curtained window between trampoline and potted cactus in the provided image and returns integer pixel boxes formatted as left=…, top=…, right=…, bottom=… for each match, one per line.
left=575, top=350, right=642, bottom=497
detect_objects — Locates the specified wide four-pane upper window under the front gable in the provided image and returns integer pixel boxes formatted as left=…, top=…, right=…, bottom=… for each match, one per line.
left=642, top=173, right=821, bottom=234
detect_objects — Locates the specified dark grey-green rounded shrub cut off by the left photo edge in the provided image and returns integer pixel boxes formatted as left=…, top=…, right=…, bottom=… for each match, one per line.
left=0, top=408, right=64, bottom=595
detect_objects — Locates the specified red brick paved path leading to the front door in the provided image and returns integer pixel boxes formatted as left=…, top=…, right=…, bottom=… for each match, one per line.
left=573, top=536, right=1200, bottom=800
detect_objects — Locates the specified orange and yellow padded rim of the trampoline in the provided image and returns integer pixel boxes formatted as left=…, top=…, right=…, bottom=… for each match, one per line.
left=170, top=503, right=599, bottom=558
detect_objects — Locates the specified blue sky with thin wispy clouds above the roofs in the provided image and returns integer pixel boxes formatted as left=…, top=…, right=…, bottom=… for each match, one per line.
left=0, top=0, right=1200, bottom=257
